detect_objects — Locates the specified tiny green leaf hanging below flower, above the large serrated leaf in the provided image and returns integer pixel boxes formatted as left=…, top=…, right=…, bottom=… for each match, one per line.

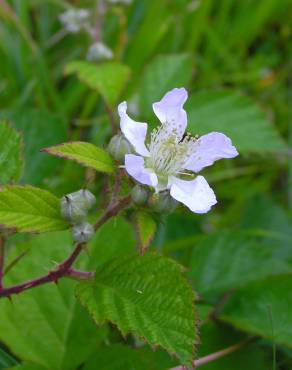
left=135, top=211, right=156, bottom=253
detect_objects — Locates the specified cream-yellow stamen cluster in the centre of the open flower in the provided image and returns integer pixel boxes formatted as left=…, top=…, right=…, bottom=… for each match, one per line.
left=148, top=124, right=195, bottom=176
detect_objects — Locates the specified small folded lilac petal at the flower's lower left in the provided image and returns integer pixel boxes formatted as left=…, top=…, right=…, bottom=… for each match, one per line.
left=125, top=154, right=158, bottom=187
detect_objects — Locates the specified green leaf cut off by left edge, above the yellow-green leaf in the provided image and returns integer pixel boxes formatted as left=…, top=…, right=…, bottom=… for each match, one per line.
left=0, top=122, right=23, bottom=184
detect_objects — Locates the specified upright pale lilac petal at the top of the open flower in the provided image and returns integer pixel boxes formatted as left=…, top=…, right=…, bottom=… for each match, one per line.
left=153, top=88, right=188, bottom=140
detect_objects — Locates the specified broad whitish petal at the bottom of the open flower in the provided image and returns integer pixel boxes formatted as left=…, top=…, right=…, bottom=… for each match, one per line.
left=169, top=176, right=217, bottom=213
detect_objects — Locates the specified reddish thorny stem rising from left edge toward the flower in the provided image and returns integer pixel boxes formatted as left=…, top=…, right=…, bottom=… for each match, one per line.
left=0, top=196, right=130, bottom=298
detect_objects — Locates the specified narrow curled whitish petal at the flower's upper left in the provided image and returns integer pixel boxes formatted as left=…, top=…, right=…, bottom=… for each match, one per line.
left=118, top=101, right=150, bottom=157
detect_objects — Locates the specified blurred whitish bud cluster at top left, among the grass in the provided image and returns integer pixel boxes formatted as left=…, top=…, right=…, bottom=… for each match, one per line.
left=59, top=8, right=90, bottom=33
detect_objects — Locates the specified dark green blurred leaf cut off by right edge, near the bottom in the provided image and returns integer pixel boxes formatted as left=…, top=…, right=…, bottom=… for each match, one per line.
left=220, top=274, right=292, bottom=347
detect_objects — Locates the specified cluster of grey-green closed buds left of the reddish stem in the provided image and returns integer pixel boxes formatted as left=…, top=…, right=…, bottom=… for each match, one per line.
left=60, top=189, right=96, bottom=243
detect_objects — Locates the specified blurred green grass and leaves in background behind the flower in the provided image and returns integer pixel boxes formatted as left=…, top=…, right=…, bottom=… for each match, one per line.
left=0, top=0, right=292, bottom=370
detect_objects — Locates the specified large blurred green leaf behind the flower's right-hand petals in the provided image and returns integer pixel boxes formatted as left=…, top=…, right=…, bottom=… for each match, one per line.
left=186, top=91, right=287, bottom=152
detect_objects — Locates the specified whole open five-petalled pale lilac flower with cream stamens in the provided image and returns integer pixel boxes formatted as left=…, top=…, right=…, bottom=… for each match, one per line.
left=118, top=88, right=238, bottom=213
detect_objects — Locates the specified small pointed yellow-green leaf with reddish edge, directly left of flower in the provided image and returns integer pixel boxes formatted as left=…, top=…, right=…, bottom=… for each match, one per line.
left=43, top=141, right=114, bottom=173
